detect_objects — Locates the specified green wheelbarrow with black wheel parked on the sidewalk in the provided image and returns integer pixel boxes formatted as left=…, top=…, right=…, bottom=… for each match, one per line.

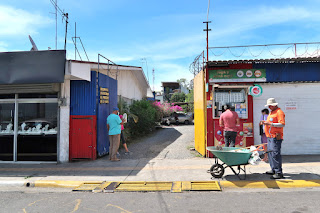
left=207, top=146, right=260, bottom=180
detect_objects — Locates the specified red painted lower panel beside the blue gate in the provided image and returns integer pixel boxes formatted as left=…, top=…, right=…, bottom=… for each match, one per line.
left=70, top=116, right=96, bottom=160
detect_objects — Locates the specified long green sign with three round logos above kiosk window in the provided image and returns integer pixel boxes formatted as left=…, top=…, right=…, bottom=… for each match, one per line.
left=209, top=69, right=267, bottom=83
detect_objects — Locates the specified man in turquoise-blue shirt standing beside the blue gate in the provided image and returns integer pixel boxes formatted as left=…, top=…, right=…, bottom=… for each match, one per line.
left=107, top=107, right=124, bottom=161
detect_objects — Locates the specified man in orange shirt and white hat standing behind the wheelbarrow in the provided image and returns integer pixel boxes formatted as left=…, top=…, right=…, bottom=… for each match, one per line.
left=263, top=98, right=286, bottom=179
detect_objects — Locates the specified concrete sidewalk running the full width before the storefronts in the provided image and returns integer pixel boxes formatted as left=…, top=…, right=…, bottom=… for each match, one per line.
left=0, top=155, right=320, bottom=188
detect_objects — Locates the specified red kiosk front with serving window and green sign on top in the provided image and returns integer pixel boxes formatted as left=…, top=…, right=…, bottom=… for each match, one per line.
left=208, top=69, right=266, bottom=154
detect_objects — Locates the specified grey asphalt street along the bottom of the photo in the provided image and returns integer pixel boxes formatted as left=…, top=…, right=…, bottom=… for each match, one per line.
left=0, top=189, right=320, bottom=213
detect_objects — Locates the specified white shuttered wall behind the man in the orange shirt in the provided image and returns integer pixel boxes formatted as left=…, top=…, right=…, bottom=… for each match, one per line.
left=253, top=83, right=320, bottom=155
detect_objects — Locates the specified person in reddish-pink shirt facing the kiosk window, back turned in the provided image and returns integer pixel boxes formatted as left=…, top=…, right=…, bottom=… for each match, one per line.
left=219, top=104, right=240, bottom=147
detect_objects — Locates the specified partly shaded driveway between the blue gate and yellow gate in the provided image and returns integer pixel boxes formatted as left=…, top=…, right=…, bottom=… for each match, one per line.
left=120, top=125, right=196, bottom=159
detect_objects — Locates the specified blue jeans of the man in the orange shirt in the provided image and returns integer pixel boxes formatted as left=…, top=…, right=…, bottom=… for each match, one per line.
left=268, top=138, right=282, bottom=174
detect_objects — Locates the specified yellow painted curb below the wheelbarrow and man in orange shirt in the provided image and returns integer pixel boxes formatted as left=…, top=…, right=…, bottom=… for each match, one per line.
left=220, top=180, right=320, bottom=188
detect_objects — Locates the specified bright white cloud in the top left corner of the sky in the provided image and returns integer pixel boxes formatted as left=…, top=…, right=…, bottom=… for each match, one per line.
left=0, top=5, right=53, bottom=36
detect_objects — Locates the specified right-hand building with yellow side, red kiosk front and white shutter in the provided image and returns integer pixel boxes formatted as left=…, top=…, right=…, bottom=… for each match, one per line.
left=194, top=57, right=320, bottom=157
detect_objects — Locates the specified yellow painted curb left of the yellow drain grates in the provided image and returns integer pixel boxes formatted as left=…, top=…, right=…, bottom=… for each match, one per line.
left=34, top=180, right=102, bottom=188
